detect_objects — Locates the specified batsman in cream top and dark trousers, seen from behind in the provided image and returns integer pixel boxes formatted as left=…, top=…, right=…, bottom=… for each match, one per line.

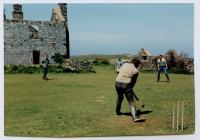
left=115, top=59, right=144, bottom=122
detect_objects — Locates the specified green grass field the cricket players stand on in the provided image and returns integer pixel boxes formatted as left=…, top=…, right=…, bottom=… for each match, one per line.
left=4, top=66, right=195, bottom=137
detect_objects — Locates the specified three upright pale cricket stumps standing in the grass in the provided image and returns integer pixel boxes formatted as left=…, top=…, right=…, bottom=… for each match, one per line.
left=172, top=100, right=184, bottom=131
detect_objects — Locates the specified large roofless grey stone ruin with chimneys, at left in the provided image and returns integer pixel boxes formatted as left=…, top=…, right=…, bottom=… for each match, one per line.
left=4, top=4, right=70, bottom=65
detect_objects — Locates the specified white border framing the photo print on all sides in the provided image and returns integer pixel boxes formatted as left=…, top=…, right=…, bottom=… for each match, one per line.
left=0, top=0, right=200, bottom=140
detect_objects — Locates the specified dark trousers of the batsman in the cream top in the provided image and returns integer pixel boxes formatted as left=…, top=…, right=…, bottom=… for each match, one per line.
left=115, top=74, right=138, bottom=114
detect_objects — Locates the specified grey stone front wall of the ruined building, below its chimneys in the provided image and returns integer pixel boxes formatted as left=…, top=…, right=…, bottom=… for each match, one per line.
left=4, top=20, right=66, bottom=65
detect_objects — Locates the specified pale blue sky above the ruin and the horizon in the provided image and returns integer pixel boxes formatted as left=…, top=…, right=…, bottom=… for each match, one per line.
left=4, top=3, right=194, bottom=57
